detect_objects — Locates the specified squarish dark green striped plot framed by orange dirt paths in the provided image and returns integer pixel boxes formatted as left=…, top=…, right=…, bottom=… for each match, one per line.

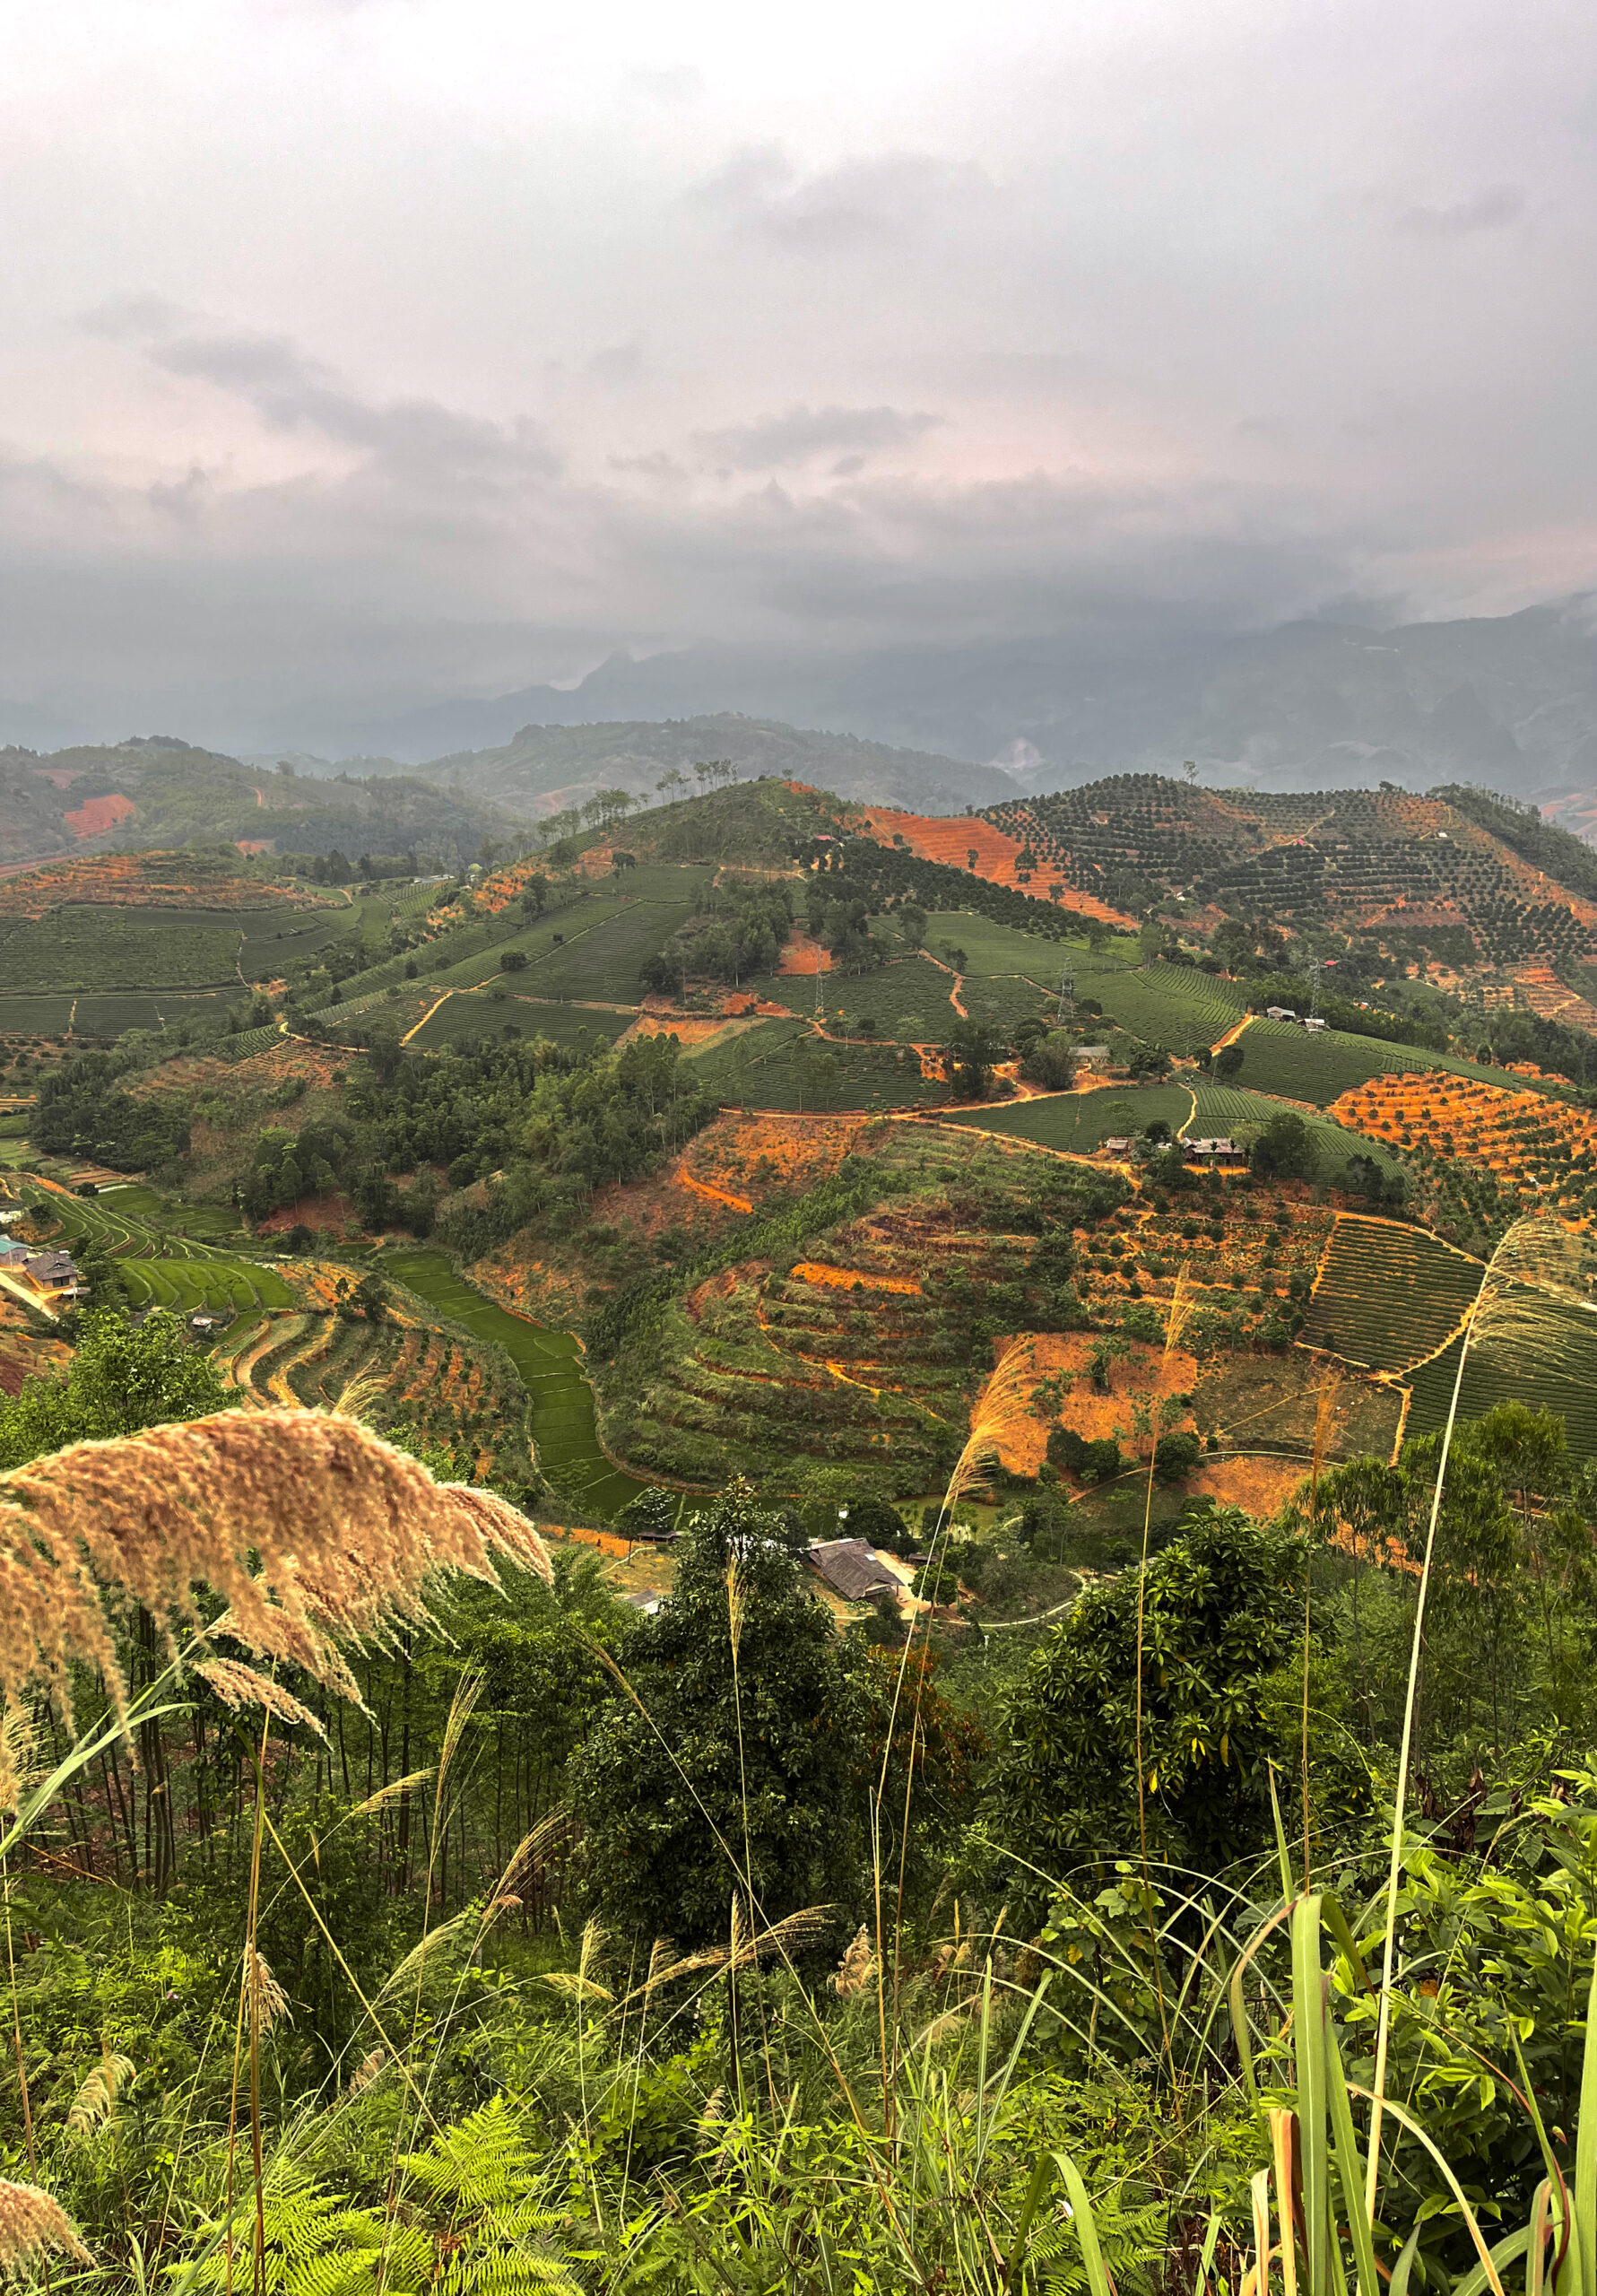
left=1301, top=1213, right=1485, bottom=1373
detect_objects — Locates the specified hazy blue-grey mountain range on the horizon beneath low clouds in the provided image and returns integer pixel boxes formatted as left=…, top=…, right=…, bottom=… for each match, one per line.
left=302, top=597, right=1597, bottom=804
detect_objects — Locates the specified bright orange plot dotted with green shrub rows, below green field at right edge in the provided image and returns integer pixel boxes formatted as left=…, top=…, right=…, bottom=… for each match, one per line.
left=1333, top=1074, right=1597, bottom=1210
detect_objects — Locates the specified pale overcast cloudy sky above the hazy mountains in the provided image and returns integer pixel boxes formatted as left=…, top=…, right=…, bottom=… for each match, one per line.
left=0, top=0, right=1597, bottom=733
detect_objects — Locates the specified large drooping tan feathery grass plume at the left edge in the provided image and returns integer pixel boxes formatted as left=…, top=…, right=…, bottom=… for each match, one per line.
left=0, top=1410, right=551, bottom=1715
